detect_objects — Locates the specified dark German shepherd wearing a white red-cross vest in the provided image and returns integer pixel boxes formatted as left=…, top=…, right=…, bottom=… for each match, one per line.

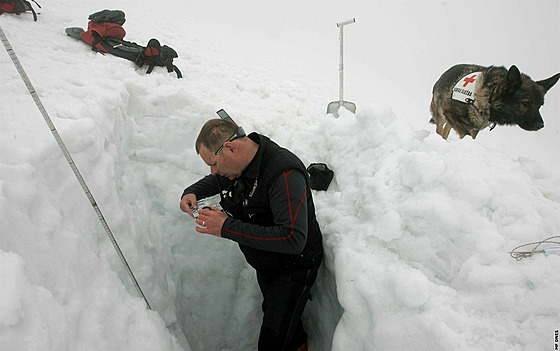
left=430, top=64, right=560, bottom=140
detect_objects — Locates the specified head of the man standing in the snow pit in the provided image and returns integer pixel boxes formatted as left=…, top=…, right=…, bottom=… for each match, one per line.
left=195, top=119, right=258, bottom=179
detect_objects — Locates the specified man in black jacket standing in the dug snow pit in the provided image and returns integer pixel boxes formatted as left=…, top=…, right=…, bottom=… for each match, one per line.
left=180, top=119, right=323, bottom=351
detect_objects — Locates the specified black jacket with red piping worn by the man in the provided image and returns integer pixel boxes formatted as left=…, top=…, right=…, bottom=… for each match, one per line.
left=183, top=133, right=323, bottom=272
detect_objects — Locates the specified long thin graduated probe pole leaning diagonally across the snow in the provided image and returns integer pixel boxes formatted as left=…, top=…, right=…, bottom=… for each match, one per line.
left=0, top=26, right=152, bottom=310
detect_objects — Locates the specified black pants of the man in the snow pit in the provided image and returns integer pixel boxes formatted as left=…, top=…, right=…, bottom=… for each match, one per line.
left=257, top=256, right=322, bottom=351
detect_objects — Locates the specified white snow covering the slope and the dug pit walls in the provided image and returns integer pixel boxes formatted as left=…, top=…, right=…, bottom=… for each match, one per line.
left=0, top=0, right=560, bottom=351
